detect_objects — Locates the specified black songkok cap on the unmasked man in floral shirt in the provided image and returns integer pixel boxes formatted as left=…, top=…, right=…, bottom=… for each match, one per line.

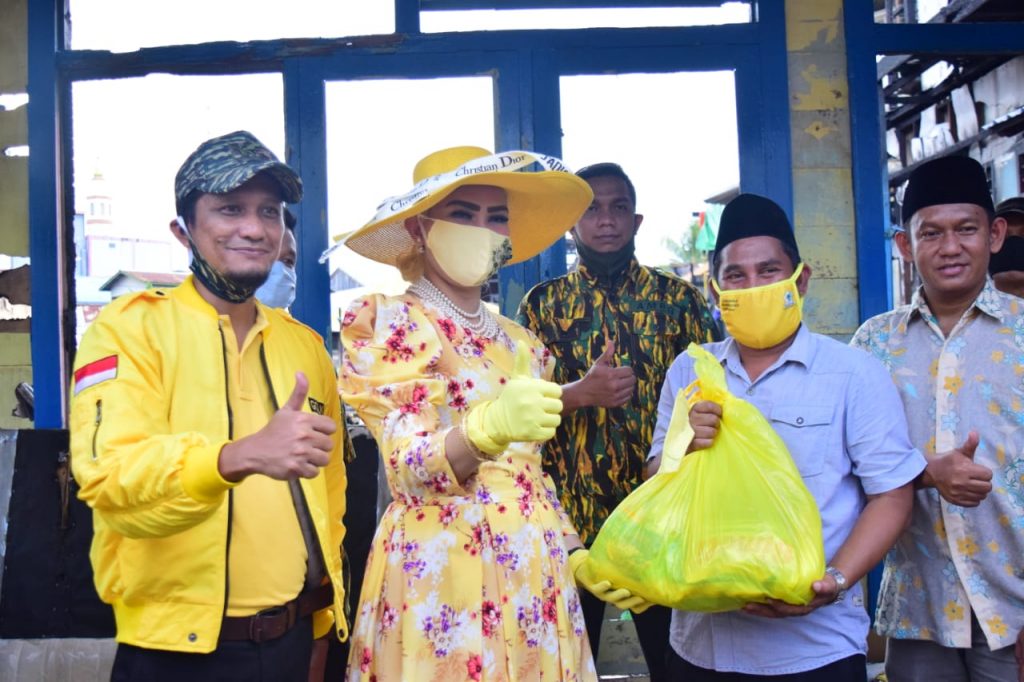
left=900, top=157, right=994, bottom=227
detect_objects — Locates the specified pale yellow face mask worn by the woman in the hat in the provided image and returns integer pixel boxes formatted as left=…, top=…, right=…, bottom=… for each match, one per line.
left=421, top=218, right=512, bottom=287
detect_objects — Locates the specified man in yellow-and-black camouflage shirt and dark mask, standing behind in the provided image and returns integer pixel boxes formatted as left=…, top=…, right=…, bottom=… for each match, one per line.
left=518, top=163, right=717, bottom=682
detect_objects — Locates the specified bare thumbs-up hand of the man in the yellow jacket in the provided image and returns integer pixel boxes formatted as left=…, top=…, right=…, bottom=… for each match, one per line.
left=218, top=372, right=338, bottom=481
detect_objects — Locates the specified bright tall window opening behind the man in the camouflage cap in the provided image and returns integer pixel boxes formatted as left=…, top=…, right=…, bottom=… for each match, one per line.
left=72, top=74, right=285, bottom=323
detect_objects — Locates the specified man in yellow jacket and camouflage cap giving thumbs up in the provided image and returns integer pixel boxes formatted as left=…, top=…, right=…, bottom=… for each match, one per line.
left=71, top=131, right=350, bottom=682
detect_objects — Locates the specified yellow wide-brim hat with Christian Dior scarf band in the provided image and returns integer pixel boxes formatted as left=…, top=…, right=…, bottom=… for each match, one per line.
left=335, top=146, right=594, bottom=265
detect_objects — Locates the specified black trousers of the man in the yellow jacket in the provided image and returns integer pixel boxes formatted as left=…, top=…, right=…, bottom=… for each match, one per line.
left=111, top=616, right=313, bottom=682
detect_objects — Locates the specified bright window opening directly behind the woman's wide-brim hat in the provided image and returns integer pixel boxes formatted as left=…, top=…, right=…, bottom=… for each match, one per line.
left=326, top=77, right=495, bottom=319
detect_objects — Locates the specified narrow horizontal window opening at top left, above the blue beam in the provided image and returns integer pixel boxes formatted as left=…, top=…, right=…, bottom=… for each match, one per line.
left=70, top=0, right=394, bottom=52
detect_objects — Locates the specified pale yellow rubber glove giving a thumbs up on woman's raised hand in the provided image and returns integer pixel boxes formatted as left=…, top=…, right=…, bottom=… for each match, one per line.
left=464, top=341, right=562, bottom=456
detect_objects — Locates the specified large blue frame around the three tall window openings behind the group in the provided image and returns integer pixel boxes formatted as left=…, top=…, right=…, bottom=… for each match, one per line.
left=29, top=0, right=793, bottom=428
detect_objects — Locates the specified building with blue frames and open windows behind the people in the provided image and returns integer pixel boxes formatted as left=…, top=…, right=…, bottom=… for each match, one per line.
left=0, top=0, right=1024, bottom=679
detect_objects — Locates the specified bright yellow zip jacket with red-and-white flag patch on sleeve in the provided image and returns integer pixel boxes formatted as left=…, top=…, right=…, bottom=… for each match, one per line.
left=71, top=278, right=348, bottom=653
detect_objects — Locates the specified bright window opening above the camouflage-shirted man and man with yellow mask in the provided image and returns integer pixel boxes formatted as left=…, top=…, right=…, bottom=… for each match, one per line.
left=561, top=72, right=739, bottom=270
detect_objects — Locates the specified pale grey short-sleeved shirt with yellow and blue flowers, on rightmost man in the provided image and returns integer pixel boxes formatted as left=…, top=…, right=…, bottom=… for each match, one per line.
left=851, top=281, right=1024, bottom=649
